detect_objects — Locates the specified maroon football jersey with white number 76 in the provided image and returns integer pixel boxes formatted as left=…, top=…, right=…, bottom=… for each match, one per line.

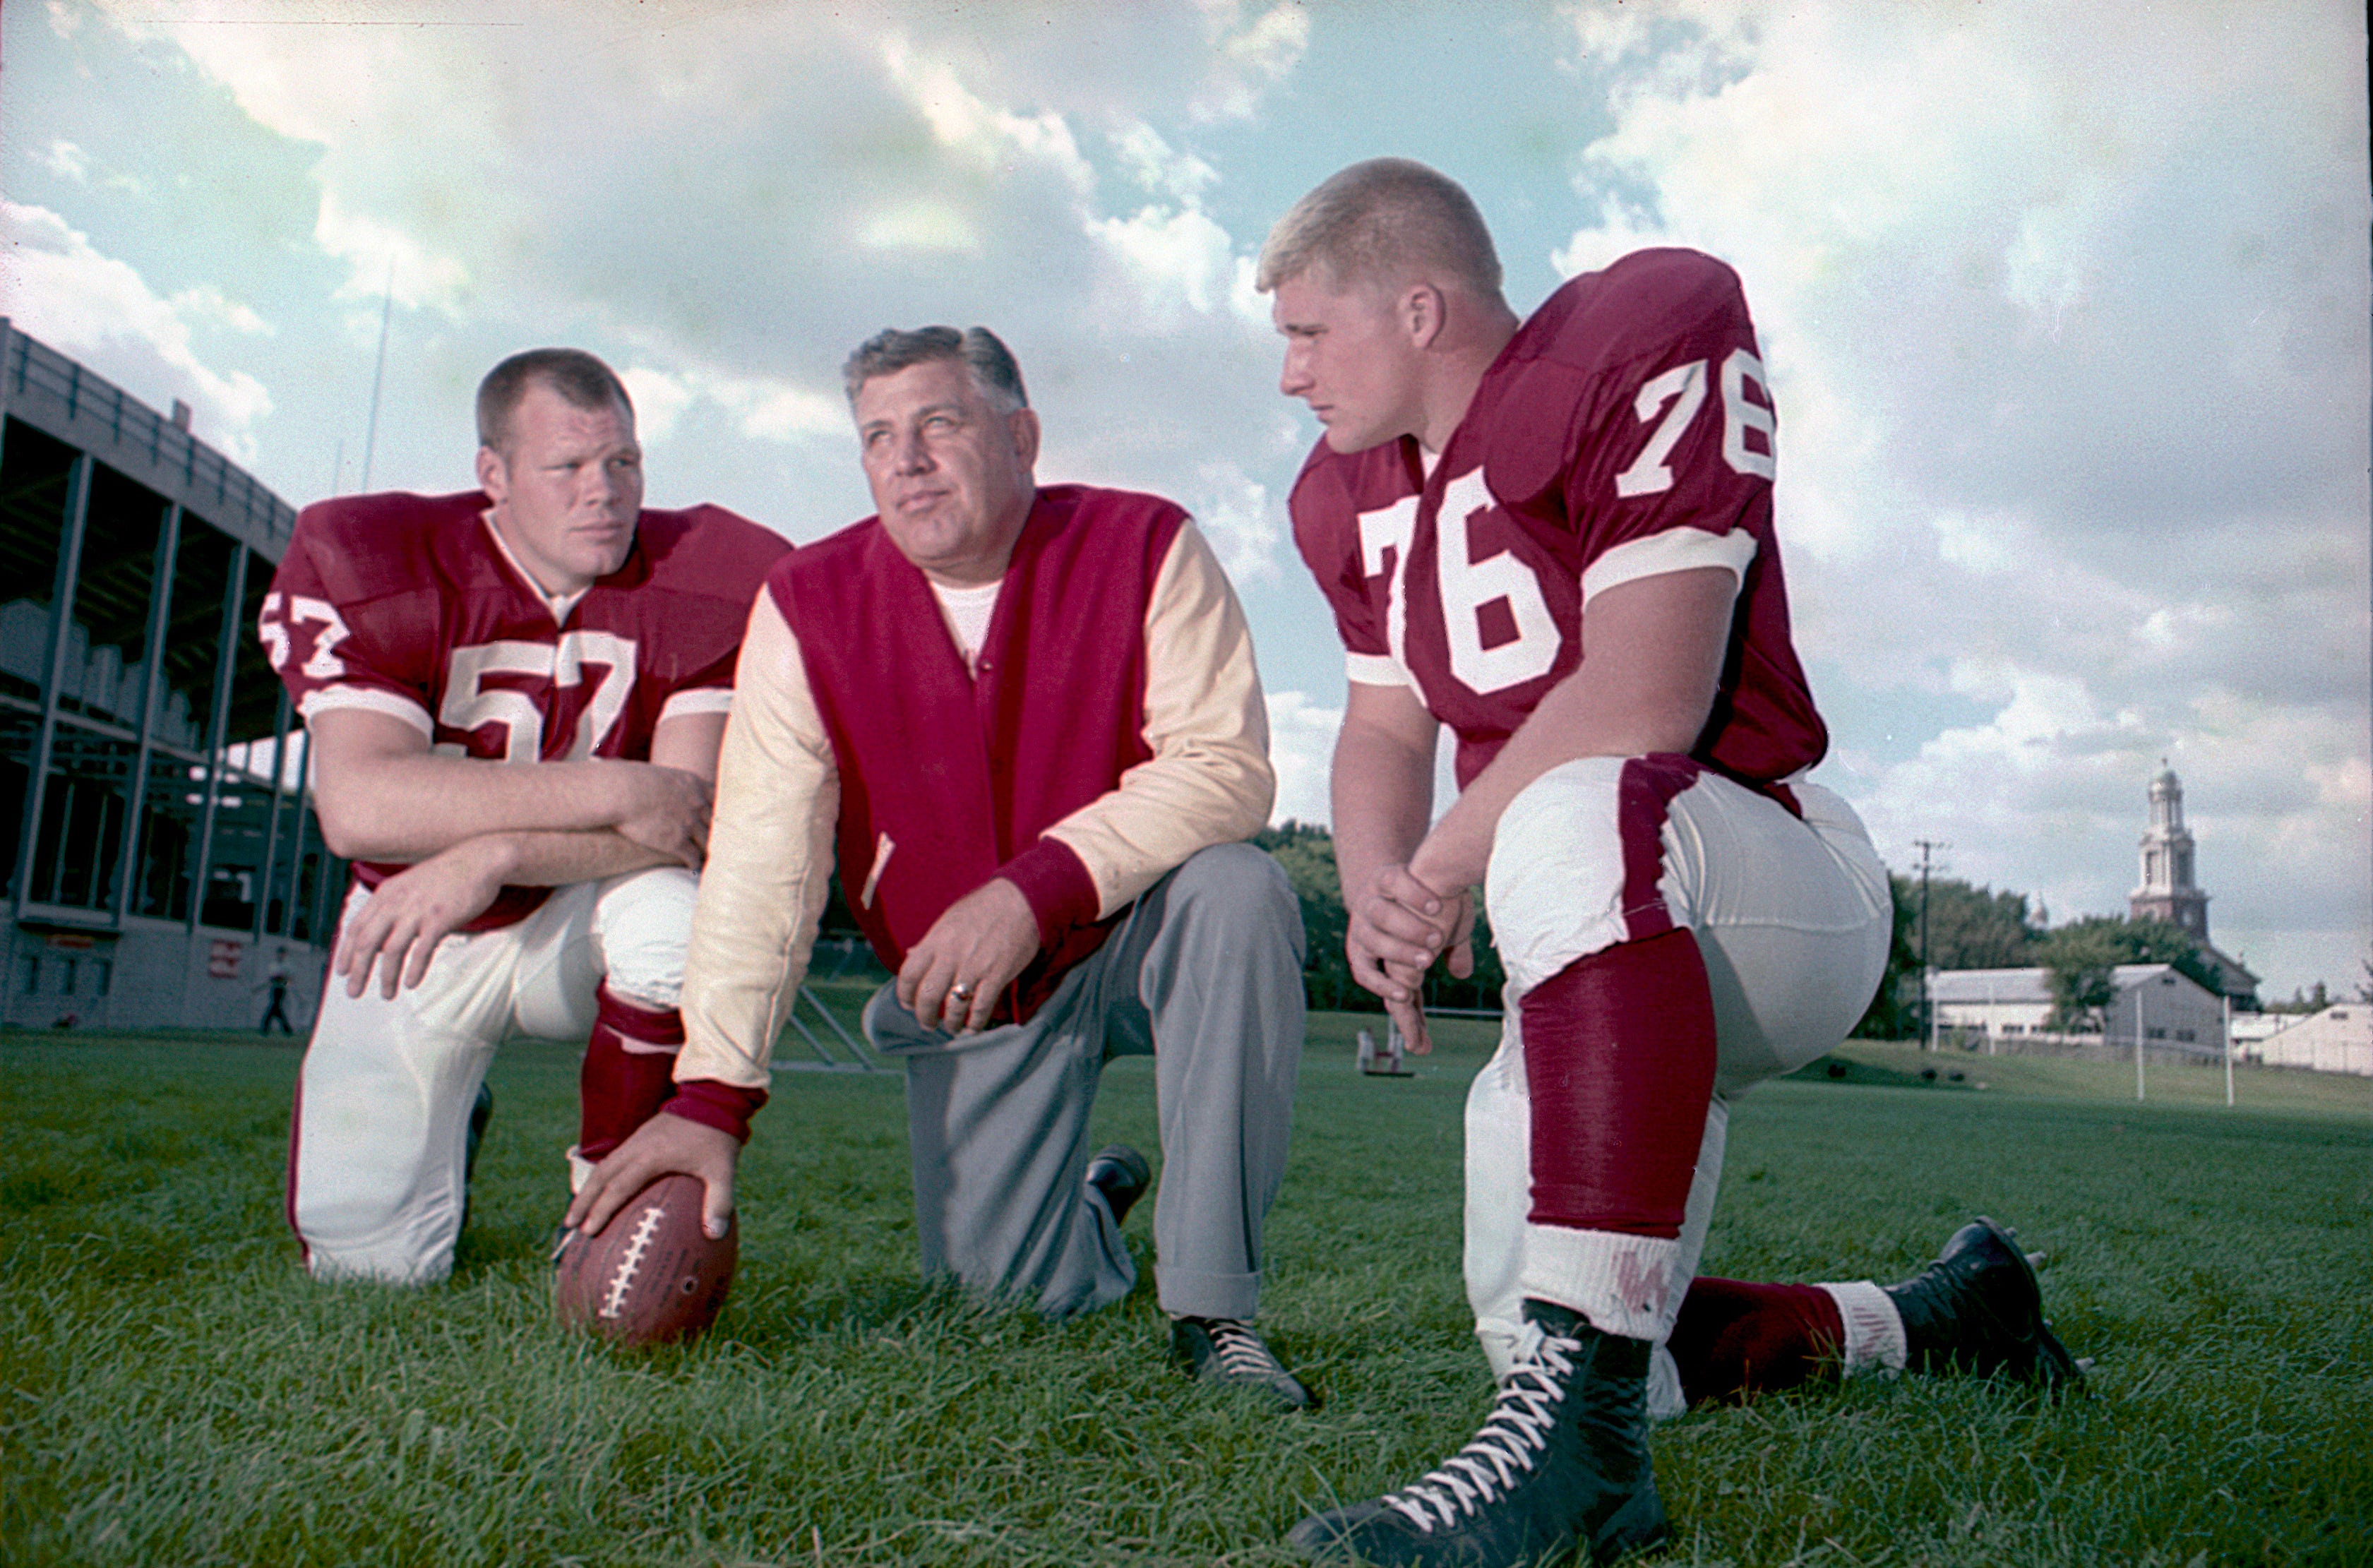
left=1291, top=249, right=1827, bottom=788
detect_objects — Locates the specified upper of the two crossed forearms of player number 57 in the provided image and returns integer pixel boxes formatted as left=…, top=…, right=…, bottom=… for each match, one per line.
left=316, top=754, right=648, bottom=861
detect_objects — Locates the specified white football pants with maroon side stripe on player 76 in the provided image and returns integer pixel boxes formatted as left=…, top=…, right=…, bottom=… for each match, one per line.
left=1466, top=757, right=1894, bottom=1414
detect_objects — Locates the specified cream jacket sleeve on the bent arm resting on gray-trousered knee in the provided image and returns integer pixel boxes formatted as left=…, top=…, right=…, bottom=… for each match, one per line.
left=1046, top=522, right=1277, bottom=921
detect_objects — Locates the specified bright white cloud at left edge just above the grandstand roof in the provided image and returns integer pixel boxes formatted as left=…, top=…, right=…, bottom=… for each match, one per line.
left=0, top=199, right=273, bottom=448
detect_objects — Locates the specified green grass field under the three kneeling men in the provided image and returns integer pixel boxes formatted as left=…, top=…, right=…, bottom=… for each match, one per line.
left=0, top=992, right=2373, bottom=1568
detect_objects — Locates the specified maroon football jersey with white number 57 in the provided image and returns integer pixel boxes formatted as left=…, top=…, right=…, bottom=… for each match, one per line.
left=258, top=491, right=790, bottom=930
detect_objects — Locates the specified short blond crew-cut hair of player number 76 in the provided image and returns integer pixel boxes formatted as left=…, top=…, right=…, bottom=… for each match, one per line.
left=1253, top=159, right=1500, bottom=299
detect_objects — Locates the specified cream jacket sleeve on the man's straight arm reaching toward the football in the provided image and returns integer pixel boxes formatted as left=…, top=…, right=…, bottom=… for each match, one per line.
left=676, top=593, right=840, bottom=1089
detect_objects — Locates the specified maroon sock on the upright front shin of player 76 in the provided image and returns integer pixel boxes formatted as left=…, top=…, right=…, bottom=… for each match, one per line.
left=1524, top=930, right=1714, bottom=1238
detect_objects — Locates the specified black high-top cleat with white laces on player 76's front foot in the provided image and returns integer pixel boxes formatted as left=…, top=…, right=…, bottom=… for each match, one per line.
left=1286, top=1300, right=1673, bottom=1568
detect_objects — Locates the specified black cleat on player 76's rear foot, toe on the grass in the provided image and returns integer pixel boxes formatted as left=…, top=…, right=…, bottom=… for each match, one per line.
left=1882, top=1214, right=2084, bottom=1390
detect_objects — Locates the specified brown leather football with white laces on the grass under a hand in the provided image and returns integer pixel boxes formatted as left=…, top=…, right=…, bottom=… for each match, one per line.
left=553, top=1174, right=741, bottom=1345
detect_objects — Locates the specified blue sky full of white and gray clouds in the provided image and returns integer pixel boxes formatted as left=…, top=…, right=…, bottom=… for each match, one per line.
left=0, top=0, right=2373, bottom=996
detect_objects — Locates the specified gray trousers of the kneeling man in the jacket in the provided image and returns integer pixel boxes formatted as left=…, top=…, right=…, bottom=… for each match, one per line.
left=863, top=844, right=1303, bottom=1317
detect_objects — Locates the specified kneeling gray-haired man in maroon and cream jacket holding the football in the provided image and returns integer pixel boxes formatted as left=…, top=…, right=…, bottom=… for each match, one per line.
left=572, top=328, right=1308, bottom=1407
